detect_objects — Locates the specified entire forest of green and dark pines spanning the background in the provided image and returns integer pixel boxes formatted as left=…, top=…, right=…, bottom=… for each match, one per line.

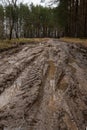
left=0, top=0, right=87, bottom=39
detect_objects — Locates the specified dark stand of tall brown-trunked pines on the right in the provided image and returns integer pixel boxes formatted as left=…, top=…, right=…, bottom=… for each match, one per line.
left=57, top=0, right=87, bottom=38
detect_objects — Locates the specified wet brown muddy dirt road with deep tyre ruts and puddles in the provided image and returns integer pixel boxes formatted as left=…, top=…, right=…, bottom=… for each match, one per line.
left=0, top=39, right=87, bottom=130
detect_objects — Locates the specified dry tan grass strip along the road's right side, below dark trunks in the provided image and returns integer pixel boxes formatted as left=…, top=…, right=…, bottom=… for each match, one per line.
left=59, top=37, right=87, bottom=47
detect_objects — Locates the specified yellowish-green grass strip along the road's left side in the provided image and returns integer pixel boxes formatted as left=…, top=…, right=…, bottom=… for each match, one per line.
left=0, top=38, right=48, bottom=49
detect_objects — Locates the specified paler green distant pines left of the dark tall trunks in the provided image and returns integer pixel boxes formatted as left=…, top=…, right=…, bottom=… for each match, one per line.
left=0, top=2, right=59, bottom=39
